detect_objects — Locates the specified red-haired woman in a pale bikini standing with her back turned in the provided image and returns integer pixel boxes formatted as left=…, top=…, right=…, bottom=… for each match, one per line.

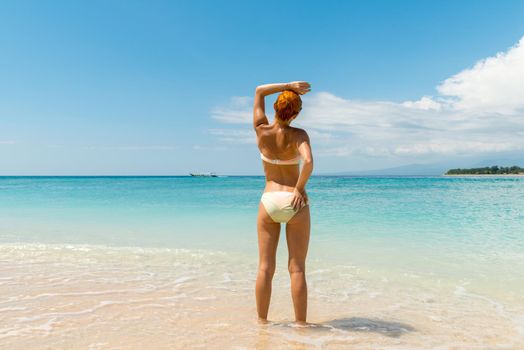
left=253, top=81, right=313, bottom=324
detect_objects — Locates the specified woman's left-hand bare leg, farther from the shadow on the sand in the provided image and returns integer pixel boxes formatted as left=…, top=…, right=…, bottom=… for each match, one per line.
left=256, top=203, right=280, bottom=320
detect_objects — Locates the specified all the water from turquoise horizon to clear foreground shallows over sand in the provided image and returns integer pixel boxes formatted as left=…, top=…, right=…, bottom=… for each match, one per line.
left=0, top=177, right=524, bottom=349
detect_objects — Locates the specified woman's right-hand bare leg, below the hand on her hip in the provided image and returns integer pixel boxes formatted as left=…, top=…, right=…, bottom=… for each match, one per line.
left=286, top=205, right=310, bottom=323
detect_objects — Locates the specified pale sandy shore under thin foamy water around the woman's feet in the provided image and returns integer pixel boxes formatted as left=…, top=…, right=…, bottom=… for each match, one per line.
left=0, top=244, right=524, bottom=349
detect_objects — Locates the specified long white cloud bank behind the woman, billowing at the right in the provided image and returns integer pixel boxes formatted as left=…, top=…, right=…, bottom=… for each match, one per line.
left=211, top=38, right=524, bottom=161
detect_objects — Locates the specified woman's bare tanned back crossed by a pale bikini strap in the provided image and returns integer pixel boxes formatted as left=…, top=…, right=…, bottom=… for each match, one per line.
left=257, top=124, right=300, bottom=190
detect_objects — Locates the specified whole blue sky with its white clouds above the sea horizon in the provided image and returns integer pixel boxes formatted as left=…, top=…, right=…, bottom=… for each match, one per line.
left=0, top=1, right=524, bottom=175
